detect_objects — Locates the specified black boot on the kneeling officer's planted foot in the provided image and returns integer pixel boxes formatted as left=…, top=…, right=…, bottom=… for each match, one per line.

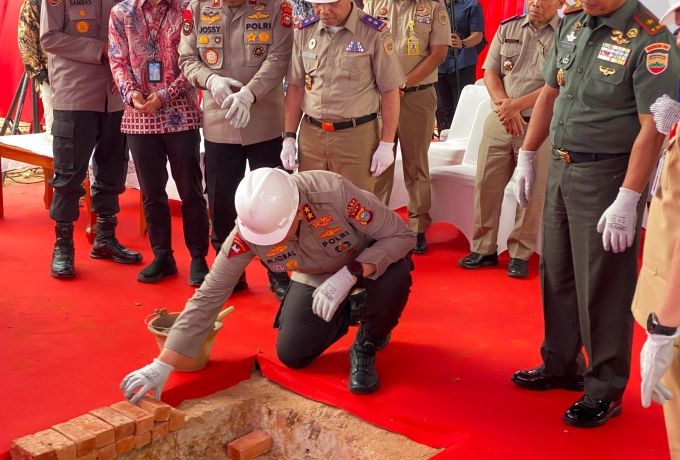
left=347, top=325, right=389, bottom=394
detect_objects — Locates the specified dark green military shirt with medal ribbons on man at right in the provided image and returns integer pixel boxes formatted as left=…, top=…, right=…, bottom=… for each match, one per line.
left=543, top=0, right=680, bottom=154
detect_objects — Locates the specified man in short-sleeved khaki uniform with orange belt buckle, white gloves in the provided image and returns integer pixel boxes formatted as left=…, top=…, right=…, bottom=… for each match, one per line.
left=281, top=0, right=406, bottom=192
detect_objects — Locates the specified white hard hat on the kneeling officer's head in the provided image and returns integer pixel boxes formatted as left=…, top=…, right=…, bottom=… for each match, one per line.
left=234, top=168, right=300, bottom=246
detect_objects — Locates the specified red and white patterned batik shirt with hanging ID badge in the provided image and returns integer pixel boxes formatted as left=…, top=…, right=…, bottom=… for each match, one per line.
left=109, top=0, right=202, bottom=134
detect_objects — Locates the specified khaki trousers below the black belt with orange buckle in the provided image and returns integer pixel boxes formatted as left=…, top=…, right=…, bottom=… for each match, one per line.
left=298, top=116, right=380, bottom=193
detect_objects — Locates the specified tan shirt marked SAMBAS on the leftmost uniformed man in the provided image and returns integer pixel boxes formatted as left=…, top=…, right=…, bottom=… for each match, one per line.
left=40, top=0, right=125, bottom=112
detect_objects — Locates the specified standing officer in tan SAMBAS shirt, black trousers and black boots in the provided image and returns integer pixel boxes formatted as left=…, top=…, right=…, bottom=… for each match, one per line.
left=40, top=0, right=142, bottom=278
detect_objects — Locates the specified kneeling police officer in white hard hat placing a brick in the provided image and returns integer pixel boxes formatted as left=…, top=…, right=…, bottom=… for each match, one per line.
left=121, top=168, right=416, bottom=403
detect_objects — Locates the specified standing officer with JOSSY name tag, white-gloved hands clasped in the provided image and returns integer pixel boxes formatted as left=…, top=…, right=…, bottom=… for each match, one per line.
left=179, top=0, right=293, bottom=300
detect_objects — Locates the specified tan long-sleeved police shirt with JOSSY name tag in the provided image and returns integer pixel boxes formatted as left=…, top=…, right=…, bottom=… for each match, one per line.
left=179, top=0, right=293, bottom=145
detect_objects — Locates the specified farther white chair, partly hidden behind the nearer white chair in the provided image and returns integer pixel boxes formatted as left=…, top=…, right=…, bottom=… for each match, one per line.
left=427, top=85, right=491, bottom=168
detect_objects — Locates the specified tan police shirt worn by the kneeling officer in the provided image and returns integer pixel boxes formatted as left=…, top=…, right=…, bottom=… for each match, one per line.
left=165, top=171, right=416, bottom=357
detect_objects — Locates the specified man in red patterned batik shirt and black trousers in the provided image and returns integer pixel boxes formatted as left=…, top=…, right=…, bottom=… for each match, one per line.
left=109, top=0, right=208, bottom=286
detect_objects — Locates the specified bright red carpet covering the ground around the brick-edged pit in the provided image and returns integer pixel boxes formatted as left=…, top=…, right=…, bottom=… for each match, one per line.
left=0, top=184, right=669, bottom=460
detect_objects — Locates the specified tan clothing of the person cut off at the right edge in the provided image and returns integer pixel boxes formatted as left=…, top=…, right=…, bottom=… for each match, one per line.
left=633, top=136, right=680, bottom=460
